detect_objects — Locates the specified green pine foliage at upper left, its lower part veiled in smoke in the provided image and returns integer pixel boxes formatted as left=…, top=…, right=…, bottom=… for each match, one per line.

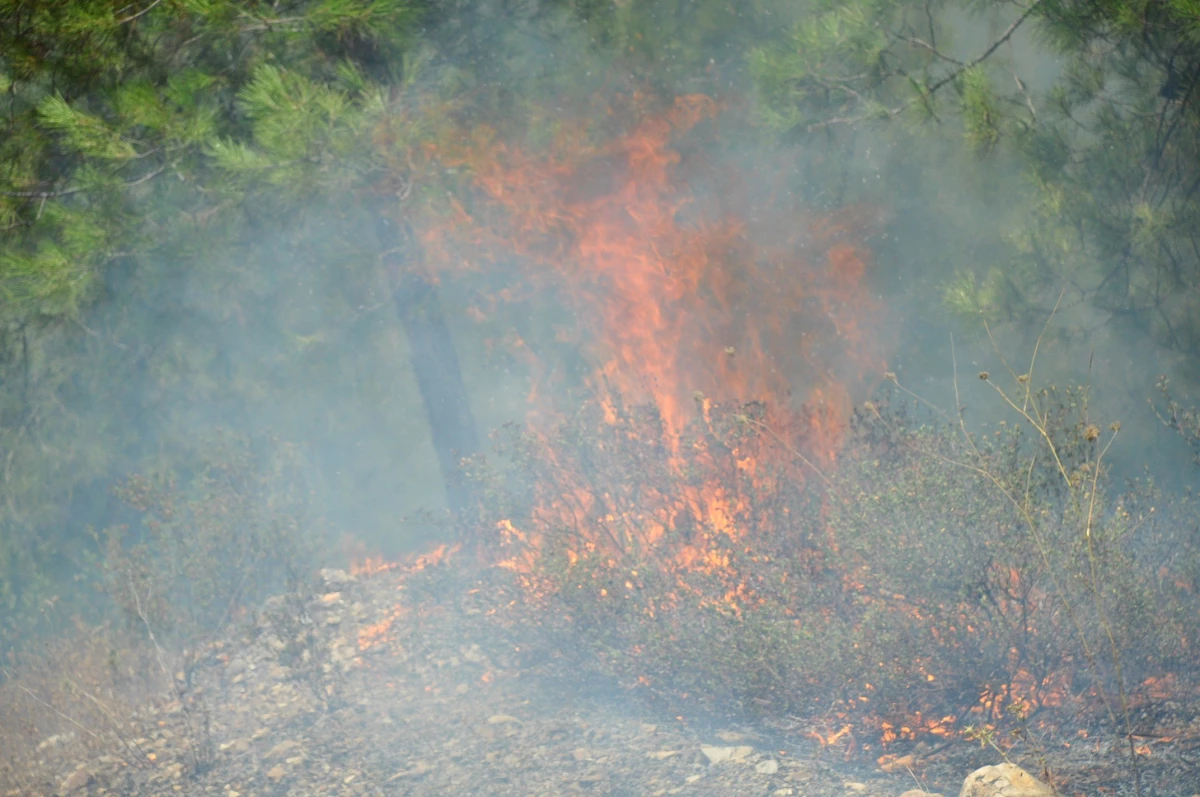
left=0, top=0, right=441, bottom=635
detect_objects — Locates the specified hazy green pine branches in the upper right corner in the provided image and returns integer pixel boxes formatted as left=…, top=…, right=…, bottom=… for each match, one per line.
left=750, top=0, right=1200, bottom=367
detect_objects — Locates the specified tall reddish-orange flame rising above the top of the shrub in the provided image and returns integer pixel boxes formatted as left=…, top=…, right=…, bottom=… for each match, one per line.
left=426, top=96, right=880, bottom=444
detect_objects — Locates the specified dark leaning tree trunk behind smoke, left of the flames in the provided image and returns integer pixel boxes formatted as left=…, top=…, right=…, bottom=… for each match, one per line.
left=376, top=215, right=479, bottom=515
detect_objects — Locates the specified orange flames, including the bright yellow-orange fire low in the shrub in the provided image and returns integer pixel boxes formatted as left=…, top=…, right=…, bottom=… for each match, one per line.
left=426, top=96, right=882, bottom=573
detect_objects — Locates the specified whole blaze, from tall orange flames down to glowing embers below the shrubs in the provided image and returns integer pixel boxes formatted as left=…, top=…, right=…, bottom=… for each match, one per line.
left=361, top=96, right=1200, bottom=753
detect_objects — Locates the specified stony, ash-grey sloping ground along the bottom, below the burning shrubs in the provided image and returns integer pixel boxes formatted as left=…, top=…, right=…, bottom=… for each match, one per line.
left=0, top=571, right=1200, bottom=797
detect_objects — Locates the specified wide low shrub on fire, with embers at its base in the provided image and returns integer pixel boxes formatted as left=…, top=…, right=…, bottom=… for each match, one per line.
left=472, top=391, right=1200, bottom=741
